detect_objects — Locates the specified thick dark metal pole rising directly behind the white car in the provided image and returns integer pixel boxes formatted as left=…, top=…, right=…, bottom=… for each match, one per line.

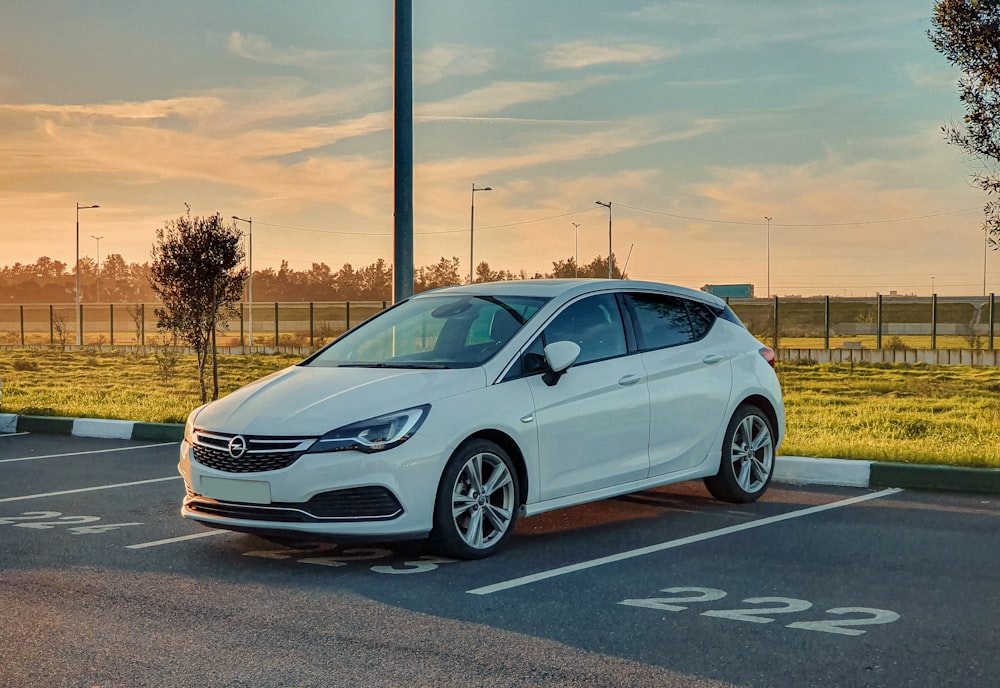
left=392, top=0, right=413, bottom=303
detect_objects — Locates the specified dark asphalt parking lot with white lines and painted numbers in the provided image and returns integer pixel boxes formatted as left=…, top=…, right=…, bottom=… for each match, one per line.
left=0, top=433, right=1000, bottom=688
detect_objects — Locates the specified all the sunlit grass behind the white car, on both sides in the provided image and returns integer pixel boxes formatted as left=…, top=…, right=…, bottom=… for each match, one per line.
left=0, top=350, right=1000, bottom=468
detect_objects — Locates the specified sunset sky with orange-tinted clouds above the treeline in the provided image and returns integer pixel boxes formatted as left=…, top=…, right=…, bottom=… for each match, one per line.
left=0, top=0, right=1000, bottom=296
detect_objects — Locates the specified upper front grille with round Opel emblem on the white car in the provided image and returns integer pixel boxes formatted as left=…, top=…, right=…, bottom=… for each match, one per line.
left=192, top=430, right=316, bottom=473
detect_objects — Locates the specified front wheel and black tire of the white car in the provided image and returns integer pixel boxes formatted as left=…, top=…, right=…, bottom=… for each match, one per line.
left=431, top=440, right=521, bottom=559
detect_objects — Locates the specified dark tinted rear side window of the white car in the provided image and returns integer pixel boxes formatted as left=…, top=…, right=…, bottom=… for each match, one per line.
left=628, top=294, right=715, bottom=351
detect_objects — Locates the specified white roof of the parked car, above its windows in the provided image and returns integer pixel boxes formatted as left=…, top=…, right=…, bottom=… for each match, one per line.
left=413, top=279, right=726, bottom=308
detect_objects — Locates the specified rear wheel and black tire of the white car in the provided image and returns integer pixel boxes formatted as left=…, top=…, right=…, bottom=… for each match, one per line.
left=705, top=405, right=774, bottom=504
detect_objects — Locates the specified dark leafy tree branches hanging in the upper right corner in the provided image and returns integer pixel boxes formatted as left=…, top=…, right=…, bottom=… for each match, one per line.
left=927, top=0, right=1000, bottom=248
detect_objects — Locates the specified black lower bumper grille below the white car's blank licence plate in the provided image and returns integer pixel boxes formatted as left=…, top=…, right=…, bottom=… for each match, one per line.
left=187, top=485, right=403, bottom=523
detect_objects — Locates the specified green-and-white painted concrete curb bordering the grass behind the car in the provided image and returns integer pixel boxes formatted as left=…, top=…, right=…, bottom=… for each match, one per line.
left=0, top=413, right=1000, bottom=494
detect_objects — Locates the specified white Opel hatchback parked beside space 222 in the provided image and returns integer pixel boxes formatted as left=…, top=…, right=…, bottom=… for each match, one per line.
left=179, top=280, right=785, bottom=558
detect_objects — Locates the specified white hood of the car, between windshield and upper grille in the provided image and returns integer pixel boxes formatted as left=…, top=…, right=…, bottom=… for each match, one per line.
left=194, top=366, right=486, bottom=435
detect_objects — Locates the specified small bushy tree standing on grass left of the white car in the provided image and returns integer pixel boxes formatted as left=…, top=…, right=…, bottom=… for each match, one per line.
left=150, top=206, right=247, bottom=403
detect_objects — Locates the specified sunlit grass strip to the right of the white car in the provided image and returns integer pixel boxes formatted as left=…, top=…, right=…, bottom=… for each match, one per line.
left=779, top=364, right=1000, bottom=468
